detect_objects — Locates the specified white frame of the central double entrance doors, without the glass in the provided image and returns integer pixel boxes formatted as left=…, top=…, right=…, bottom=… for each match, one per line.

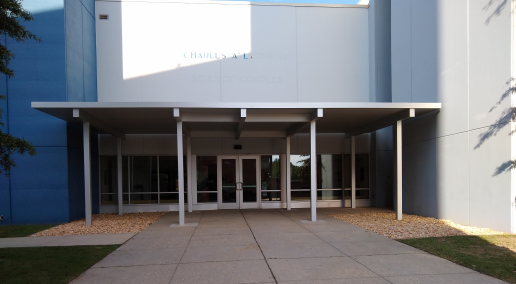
left=217, top=155, right=261, bottom=209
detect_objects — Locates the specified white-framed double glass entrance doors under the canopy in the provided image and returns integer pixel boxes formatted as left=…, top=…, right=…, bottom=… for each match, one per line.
left=217, top=156, right=260, bottom=209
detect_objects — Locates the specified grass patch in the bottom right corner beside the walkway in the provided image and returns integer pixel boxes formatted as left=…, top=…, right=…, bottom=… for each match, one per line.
left=398, top=235, right=516, bottom=283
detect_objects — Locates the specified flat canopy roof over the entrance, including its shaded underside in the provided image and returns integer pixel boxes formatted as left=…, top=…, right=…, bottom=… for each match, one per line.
left=32, top=102, right=441, bottom=138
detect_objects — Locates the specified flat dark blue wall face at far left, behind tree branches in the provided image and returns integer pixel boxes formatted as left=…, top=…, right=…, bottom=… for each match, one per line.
left=0, top=0, right=69, bottom=224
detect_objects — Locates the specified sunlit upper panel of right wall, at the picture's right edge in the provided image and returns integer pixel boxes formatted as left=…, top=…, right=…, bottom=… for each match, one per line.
left=469, top=0, right=512, bottom=129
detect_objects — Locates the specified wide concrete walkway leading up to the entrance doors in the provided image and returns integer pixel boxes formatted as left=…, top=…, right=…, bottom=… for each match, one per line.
left=69, top=208, right=505, bottom=284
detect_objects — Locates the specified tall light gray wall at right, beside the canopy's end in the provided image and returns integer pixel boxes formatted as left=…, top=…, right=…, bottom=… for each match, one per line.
left=391, top=0, right=514, bottom=232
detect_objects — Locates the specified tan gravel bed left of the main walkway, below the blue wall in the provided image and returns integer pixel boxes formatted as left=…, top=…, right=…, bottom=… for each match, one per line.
left=31, top=212, right=166, bottom=237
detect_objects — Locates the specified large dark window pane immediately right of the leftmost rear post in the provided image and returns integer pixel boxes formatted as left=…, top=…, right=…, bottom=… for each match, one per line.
left=131, top=156, right=153, bottom=193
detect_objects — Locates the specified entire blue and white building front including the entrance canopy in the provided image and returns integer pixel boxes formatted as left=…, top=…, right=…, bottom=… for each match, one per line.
left=0, top=0, right=516, bottom=233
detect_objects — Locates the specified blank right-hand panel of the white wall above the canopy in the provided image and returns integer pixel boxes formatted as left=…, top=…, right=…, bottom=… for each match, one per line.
left=297, top=8, right=369, bottom=102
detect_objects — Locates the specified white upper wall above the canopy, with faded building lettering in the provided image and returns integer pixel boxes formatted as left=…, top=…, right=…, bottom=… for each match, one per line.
left=96, top=1, right=369, bottom=102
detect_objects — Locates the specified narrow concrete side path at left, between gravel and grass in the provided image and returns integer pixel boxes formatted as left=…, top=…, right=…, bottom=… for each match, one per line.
left=0, top=233, right=136, bottom=248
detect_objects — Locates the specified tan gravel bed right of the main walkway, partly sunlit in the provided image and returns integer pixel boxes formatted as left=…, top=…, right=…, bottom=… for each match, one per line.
left=330, top=213, right=504, bottom=239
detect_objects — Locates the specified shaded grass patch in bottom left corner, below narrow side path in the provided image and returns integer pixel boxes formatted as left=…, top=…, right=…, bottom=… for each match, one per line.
left=0, top=245, right=119, bottom=284
